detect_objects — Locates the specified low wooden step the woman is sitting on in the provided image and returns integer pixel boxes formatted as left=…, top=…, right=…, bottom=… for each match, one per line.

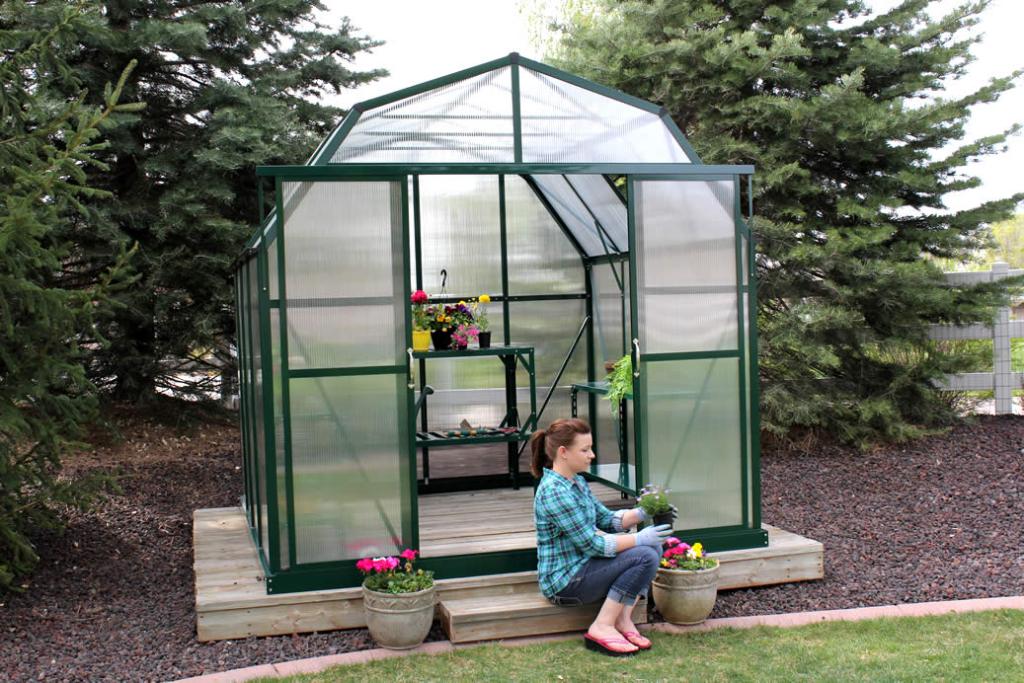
left=437, top=591, right=647, bottom=643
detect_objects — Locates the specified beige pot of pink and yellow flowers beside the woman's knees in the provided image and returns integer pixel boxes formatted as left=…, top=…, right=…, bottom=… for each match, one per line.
left=652, top=537, right=719, bottom=626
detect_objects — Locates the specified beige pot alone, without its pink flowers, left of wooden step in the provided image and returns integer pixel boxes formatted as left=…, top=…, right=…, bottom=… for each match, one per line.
left=362, top=586, right=436, bottom=650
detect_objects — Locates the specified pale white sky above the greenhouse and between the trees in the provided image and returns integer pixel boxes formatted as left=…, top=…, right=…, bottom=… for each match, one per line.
left=324, top=0, right=1024, bottom=210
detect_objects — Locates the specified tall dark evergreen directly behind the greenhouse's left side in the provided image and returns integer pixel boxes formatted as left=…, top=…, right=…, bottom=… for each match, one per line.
left=58, top=0, right=385, bottom=400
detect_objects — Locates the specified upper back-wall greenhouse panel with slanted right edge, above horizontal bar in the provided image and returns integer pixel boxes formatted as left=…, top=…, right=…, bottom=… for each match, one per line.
left=505, top=175, right=586, bottom=296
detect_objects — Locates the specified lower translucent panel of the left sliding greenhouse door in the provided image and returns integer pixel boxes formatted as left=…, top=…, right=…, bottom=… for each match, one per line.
left=290, top=375, right=406, bottom=564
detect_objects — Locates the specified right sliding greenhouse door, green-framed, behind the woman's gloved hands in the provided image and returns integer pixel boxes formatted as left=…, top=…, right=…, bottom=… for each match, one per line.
left=628, top=176, right=763, bottom=550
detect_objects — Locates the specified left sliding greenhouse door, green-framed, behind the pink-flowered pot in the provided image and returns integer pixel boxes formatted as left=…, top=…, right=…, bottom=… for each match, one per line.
left=269, top=176, right=416, bottom=573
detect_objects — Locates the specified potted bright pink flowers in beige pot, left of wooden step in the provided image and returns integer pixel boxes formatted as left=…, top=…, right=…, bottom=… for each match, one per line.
left=355, top=550, right=436, bottom=650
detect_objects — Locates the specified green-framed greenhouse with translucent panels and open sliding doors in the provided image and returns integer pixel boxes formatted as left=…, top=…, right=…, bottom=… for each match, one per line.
left=236, top=53, right=768, bottom=593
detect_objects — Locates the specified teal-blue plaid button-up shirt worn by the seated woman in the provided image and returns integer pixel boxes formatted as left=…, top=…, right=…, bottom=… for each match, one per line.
left=534, top=469, right=625, bottom=598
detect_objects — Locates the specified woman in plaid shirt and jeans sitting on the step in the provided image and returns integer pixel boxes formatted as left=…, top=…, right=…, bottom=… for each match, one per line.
left=530, top=419, right=672, bottom=656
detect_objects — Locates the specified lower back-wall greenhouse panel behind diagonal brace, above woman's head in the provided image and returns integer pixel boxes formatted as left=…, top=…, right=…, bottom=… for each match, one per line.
left=509, top=299, right=587, bottom=427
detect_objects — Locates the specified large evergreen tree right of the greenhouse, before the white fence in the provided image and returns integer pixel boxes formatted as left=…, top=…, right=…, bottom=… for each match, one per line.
left=554, top=0, right=1024, bottom=443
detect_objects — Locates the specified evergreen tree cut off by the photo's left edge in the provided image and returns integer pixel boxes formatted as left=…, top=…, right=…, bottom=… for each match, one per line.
left=0, top=0, right=139, bottom=591
